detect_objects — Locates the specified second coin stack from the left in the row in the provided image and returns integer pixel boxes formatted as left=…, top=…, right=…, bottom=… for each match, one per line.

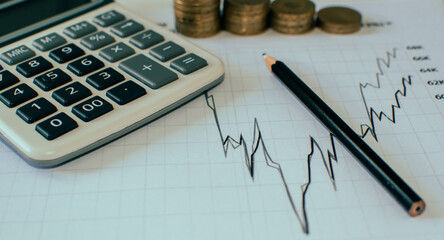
left=223, top=0, right=270, bottom=35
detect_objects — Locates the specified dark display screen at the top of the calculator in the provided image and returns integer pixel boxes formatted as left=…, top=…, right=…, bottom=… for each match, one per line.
left=0, top=0, right=103, bottom=43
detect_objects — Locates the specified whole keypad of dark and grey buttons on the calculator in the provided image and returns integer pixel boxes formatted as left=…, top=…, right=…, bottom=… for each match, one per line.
left=0, top=7, right=213, bottom=146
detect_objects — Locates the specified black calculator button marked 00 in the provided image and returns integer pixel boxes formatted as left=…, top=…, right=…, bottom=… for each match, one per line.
left=72, top=96, right=113, bottom=122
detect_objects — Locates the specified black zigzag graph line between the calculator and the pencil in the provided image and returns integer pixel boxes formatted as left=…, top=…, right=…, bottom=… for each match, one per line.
left=205, top=92, right=338, bottom=234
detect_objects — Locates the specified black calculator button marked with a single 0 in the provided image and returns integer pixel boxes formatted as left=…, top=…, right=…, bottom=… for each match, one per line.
left=35, top=113, right=79, bottom=140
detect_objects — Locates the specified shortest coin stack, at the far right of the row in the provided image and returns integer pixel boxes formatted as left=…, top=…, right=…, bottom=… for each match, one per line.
left=316, top=7, right=361, bottom=34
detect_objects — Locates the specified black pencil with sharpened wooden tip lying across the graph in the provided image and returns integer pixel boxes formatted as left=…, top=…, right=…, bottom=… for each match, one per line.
left=264, top=54, right=425, bottom=217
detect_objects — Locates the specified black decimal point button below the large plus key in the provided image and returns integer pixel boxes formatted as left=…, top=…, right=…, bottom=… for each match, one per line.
left=106, top=81, right=146, bottom=105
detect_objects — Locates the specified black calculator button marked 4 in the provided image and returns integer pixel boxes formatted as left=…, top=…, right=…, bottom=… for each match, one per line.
left=0, top=83, right=38, bottom=108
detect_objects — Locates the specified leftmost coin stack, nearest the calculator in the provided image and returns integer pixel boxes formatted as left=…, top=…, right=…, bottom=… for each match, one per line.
left=174, top=0, right=220, bottom=38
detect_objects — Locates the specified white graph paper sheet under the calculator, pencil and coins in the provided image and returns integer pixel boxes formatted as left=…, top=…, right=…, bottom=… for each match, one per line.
left=0, top=1, right=444, bottom=239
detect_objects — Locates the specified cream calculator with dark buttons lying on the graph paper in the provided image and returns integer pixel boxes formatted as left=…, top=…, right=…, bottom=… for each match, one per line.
left=0, top=0, right=224, bottom=168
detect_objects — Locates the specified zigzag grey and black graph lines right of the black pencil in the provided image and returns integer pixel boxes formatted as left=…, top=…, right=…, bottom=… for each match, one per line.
left=359, top=48, right=412, bottom=141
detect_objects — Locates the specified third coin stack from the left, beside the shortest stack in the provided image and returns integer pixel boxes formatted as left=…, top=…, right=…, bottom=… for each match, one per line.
left=270, top=0, right=315, bottom=34
